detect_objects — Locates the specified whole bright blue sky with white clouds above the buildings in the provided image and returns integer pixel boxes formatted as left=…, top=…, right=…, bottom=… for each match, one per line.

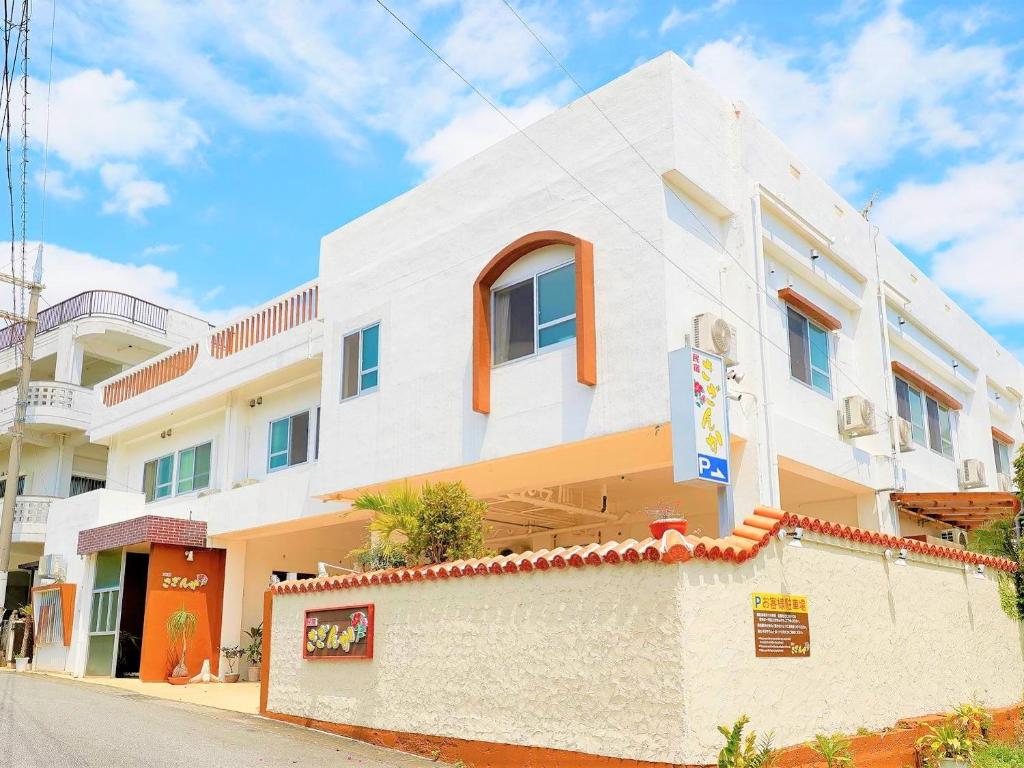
left=19, top=0, right=1024, bottom=354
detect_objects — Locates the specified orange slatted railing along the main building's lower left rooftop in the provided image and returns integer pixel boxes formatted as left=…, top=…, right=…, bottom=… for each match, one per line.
left=103, top=284, right=319, bottom=407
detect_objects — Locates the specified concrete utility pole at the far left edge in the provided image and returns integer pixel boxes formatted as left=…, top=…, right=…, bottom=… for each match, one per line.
left=0, top=243, right=43, bottom=611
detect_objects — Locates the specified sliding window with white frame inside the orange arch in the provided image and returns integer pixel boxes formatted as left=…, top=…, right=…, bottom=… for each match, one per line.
left=492, top=261, right=575, bottom=366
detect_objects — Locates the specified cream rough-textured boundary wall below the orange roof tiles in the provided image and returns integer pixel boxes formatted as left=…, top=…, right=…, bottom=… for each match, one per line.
left=267, top=537, right=1024, bottom=765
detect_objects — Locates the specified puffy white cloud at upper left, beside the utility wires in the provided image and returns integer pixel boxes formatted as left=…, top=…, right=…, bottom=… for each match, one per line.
left=38, top=70, right=206, bottom=169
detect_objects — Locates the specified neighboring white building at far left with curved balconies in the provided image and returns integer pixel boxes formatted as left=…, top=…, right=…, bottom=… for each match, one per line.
left=0, top=291, right=209, bottom=608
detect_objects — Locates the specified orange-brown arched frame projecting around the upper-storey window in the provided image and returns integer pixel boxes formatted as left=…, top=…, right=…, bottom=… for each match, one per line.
left=473, top=229, right=597, bottom=414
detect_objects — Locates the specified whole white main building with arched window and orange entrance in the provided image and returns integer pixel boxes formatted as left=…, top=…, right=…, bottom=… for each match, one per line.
left=39, top=54, right=1024, bottom=679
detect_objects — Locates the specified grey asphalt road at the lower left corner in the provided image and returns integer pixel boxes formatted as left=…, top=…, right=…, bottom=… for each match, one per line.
left=0, top=672, right=448, bottom=768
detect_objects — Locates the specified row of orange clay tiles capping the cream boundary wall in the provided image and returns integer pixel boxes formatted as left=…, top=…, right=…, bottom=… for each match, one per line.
left=271, top=507, right=1017, bottom=594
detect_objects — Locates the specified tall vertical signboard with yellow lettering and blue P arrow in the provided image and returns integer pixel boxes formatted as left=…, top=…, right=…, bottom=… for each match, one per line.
left=669, top=347, right=731, bottom=485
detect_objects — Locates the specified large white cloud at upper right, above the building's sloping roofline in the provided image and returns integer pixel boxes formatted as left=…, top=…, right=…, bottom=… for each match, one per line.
left=693, top=5, right=1008, bottom=188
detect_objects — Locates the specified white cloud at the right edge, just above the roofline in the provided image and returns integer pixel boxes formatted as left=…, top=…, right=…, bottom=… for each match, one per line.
left=876, top=158, right=1024, bottom=324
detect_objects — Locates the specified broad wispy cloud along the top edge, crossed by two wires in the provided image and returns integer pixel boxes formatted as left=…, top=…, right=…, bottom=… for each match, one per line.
left=51, top=0, right=577, bottom=175
